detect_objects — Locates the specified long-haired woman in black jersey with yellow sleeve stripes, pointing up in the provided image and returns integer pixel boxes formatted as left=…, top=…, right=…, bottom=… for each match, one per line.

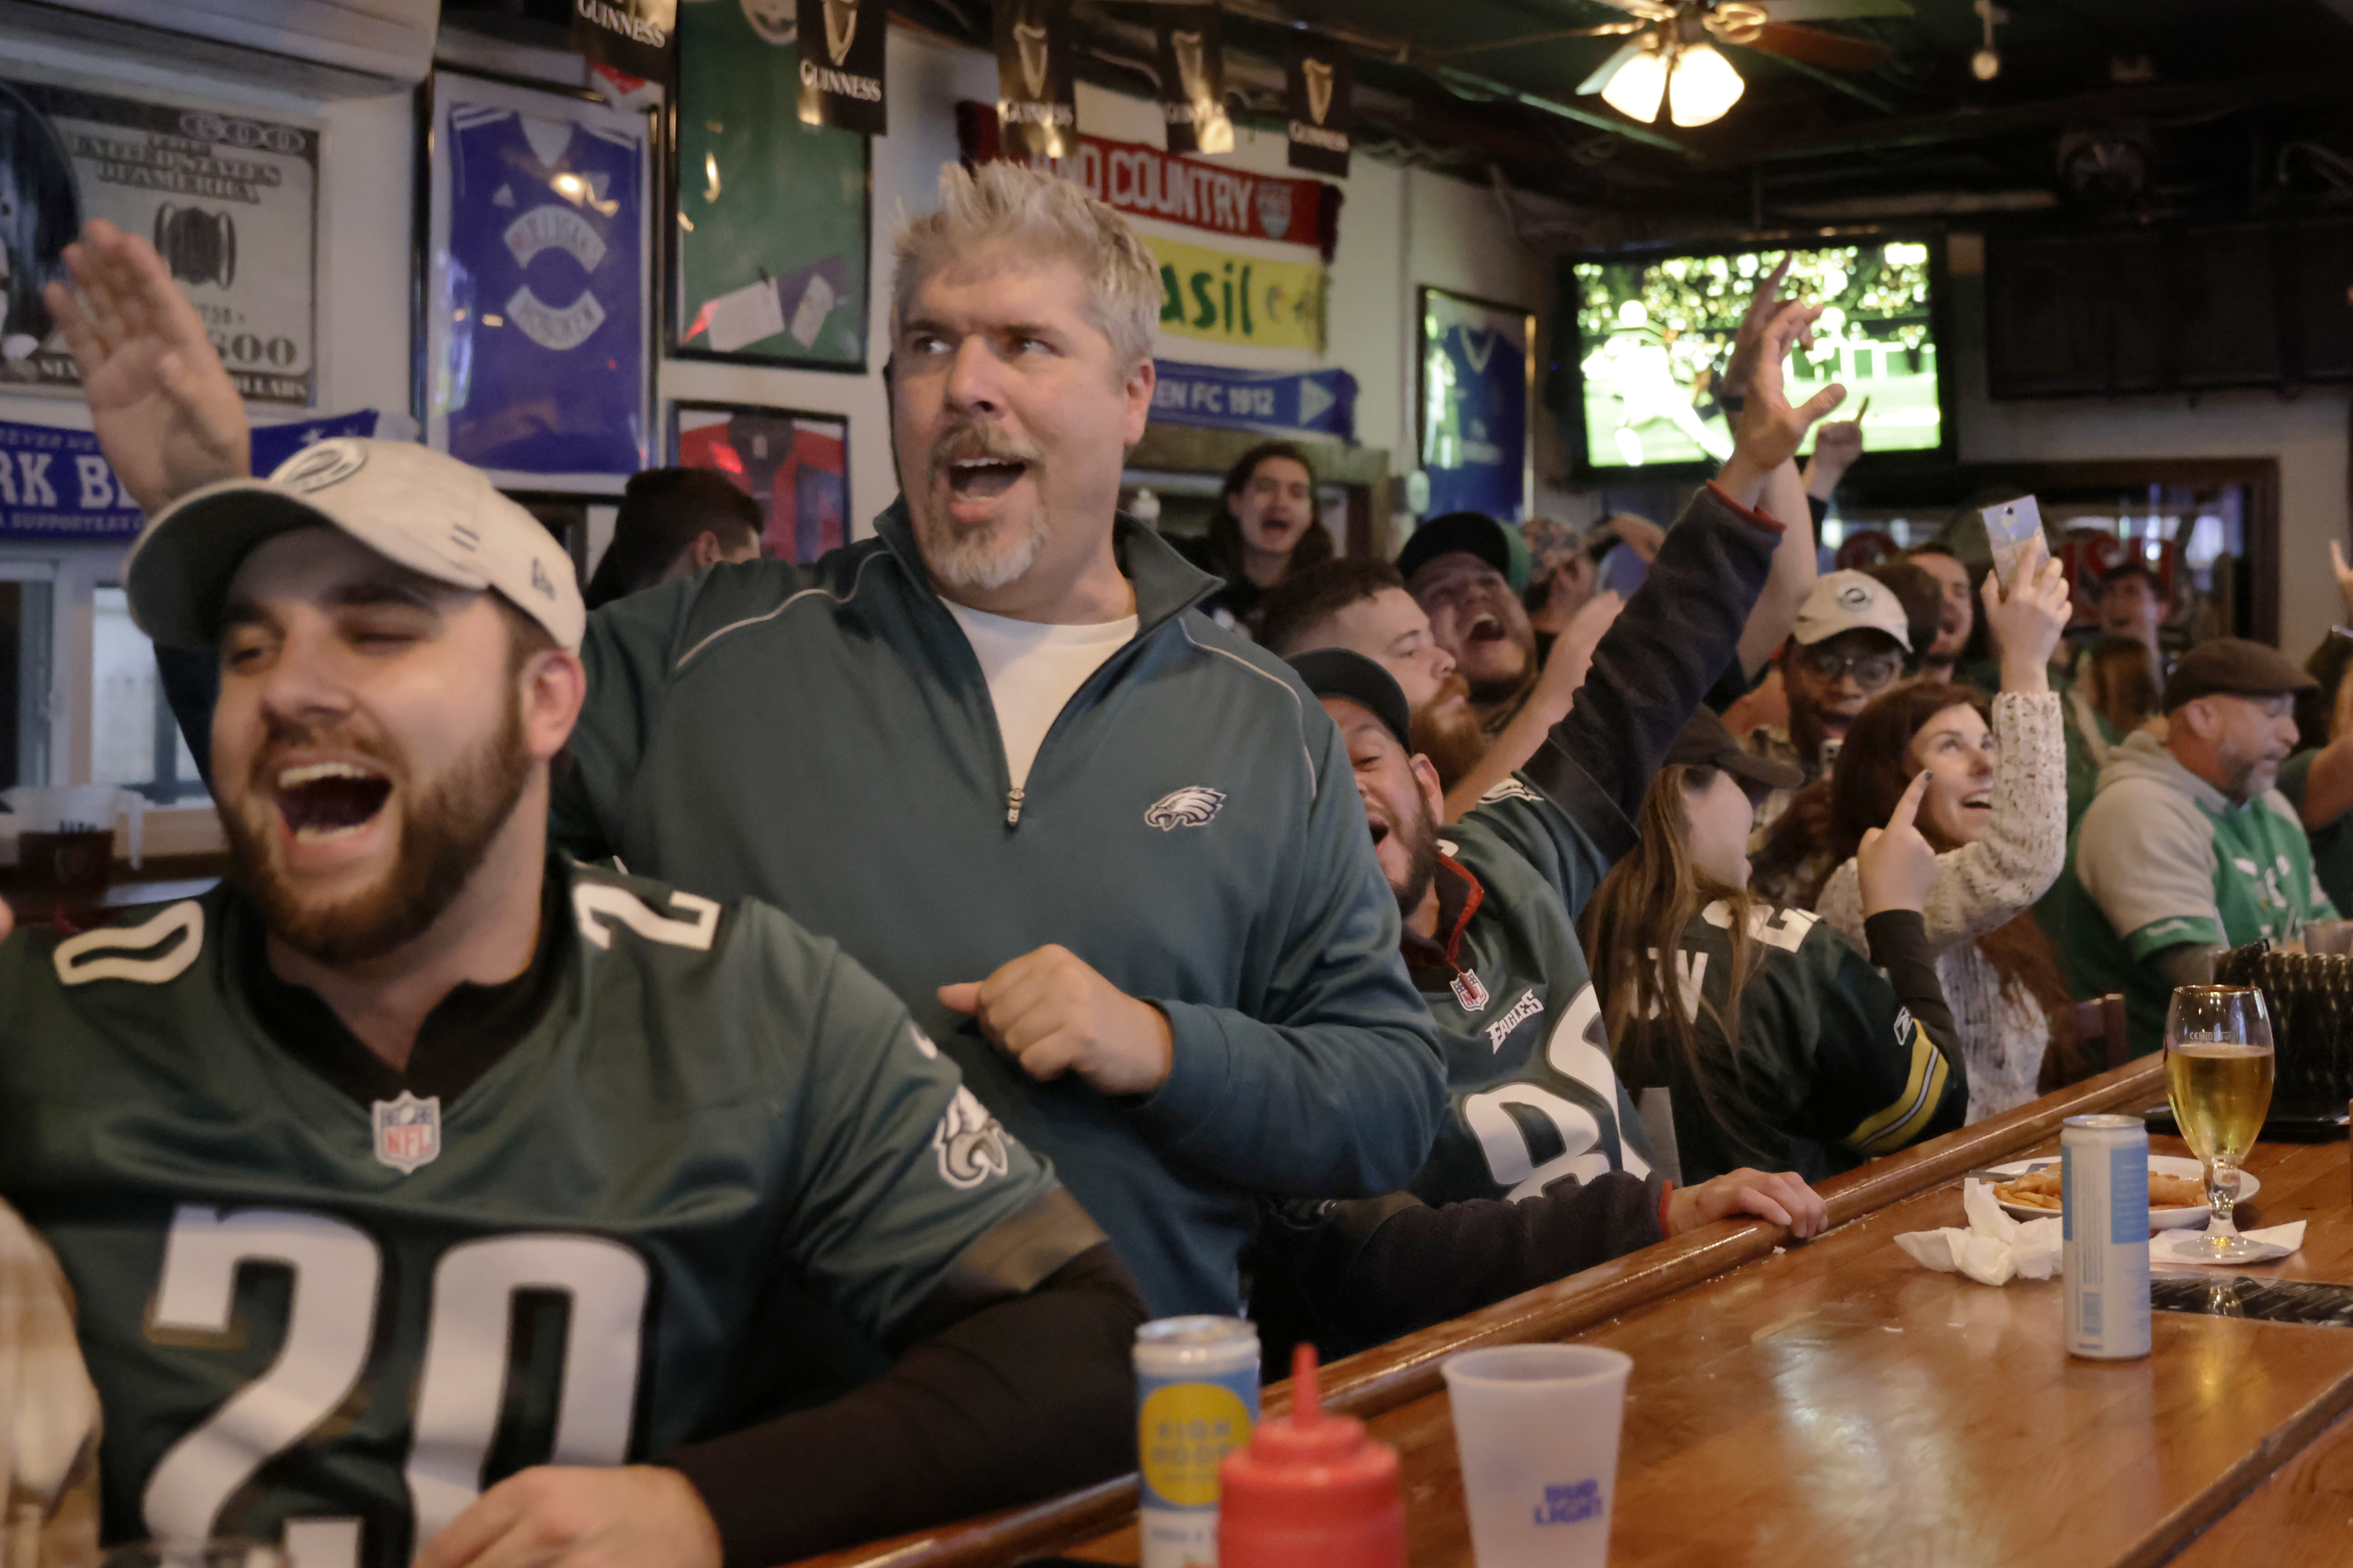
left=1581, top=708, right=1967, bottom=1180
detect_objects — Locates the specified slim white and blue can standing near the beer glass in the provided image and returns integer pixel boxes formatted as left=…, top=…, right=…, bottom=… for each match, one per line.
left=2059, top=1117, right=2148, bottom=1361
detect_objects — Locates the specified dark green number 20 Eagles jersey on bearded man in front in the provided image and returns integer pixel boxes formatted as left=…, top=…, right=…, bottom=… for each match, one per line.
left=0, top=867, right=1054, bottom=1568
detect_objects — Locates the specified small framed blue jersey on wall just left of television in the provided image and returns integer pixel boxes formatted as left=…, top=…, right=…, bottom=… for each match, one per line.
left=1414, top=287, right=1536, bottom=522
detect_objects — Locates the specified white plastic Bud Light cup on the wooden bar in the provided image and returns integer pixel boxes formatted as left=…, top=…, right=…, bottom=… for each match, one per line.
left=1438, top=1344, right=1633, bottom=1568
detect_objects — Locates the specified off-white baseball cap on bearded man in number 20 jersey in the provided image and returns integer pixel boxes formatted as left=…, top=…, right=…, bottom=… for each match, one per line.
left=122, top=435, right=588, bottom=649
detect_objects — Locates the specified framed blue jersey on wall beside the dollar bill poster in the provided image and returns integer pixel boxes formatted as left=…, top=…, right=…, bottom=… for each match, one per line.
left=417, top=71, right=657, bottom=489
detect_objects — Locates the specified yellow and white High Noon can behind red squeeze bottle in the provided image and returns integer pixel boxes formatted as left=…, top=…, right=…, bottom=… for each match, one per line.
left=1137, top=1317, right=1259, bottom=1568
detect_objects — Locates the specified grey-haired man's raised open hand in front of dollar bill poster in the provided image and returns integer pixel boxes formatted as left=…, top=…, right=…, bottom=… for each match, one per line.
left=42, top=219, right=252, bottom=515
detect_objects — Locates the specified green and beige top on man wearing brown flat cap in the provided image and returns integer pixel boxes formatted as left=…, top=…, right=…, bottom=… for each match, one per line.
left=2035, top=733, right=2337, bottom=1053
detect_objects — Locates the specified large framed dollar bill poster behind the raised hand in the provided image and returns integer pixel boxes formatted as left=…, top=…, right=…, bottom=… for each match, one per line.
left=0, top=77, right=318, bottom=407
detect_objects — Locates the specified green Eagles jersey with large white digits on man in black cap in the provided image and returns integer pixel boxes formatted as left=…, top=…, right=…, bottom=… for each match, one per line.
left=1409, top=776, right=1649, bottom=1206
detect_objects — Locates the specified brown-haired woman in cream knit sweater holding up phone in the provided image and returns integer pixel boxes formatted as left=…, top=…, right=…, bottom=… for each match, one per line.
left=1814, top=552, right=2068, bottom=1121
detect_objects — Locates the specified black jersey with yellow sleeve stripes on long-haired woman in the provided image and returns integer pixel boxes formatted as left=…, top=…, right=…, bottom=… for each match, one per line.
left=1619, top=901, right=1970, bottom=1182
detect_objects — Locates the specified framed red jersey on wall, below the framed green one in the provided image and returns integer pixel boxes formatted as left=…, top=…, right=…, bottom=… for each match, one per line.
left=671, top=402, right=849, bottom=562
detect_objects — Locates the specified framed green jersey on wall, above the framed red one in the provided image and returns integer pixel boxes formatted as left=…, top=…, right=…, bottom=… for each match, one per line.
left=668, top=0, right=873, bottom=372
